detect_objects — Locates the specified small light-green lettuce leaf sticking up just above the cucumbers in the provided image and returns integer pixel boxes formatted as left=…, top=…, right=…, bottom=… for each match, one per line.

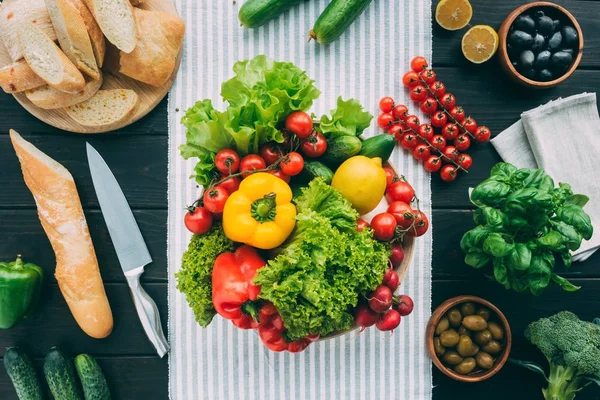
left=319, top=96, right=373, bottom=137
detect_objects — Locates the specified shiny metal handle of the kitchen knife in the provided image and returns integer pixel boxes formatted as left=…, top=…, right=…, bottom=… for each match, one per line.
left=125, top=268, right=169, bottom=358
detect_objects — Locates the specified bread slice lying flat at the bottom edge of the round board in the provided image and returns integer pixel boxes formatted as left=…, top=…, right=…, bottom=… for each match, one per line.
left=65, top=89, right=139, bottom=129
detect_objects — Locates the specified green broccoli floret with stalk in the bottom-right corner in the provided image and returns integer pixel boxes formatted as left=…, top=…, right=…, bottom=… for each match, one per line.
left=525, top=311, right=600, bottom=400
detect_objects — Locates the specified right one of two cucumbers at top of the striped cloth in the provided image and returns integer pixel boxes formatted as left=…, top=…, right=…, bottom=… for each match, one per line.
left=309, top=0, right=371, bottom=44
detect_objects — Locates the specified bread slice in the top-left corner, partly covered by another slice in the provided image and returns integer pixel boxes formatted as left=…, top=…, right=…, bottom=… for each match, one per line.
left=0, top=0, right=56, bottom=61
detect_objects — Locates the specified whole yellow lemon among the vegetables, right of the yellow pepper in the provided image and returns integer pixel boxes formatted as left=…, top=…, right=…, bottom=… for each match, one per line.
left=331, top=156, right=386, bottom=215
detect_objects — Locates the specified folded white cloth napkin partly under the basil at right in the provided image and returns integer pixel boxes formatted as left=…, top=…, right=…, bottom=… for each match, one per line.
left=492, top=93, right=600, bottom=261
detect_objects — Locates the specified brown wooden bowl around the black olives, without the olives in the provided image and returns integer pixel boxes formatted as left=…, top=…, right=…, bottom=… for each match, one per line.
left=498, top=1, right=583, bottom=89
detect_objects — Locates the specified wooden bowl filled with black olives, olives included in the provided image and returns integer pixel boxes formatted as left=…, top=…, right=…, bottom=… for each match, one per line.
left=498, top=1, right=583, bottom=88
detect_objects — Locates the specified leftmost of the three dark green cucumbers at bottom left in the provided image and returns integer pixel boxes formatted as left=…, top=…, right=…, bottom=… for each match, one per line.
left=4, top=347, right=44, bottom=400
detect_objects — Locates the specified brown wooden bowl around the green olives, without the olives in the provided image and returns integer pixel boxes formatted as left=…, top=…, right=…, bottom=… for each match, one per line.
left=425, top=296, right=512, bottom=382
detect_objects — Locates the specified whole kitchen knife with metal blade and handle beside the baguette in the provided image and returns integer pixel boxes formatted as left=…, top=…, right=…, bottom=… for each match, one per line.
left=86, top=143, right=169, bottom=358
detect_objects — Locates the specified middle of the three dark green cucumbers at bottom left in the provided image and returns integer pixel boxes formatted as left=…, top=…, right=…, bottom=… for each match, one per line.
left=44, top=347, right=83, bottom=400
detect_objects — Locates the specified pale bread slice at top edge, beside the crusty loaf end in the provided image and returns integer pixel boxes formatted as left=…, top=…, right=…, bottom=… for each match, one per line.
left=85, top=0, right=138, bottom=53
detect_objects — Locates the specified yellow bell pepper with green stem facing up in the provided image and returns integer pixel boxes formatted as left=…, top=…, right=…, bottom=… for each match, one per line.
left=223, top=172, right=296, bottom=250
